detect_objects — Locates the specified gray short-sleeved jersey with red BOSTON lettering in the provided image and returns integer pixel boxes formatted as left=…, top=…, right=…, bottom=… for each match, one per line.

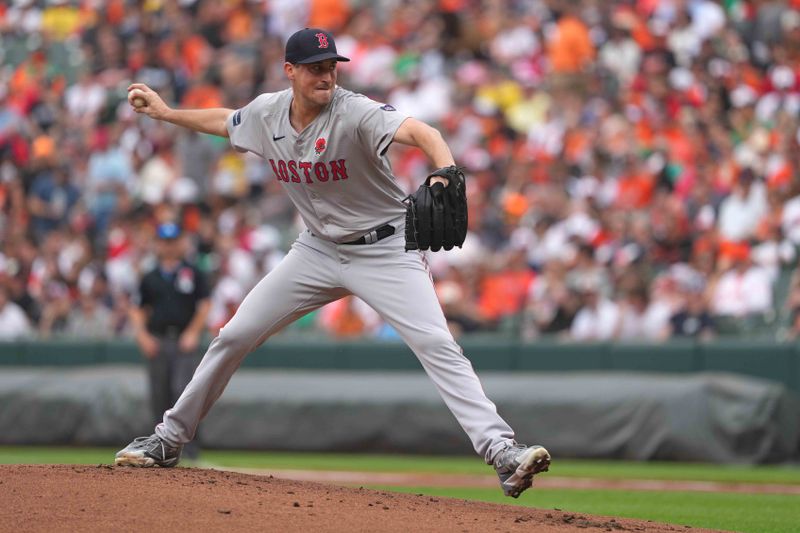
left=227, top=87, right=407, bottom=242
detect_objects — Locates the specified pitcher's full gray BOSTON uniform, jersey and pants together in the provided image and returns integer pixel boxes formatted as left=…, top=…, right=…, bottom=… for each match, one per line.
left=156, top=88, right=514, bottom=463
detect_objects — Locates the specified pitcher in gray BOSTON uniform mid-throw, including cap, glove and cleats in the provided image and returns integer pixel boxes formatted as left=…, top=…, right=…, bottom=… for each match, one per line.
left=116, top=28, right=550, bottom=498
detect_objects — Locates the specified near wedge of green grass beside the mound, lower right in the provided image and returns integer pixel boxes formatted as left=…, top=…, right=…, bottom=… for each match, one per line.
left=371, top=486, right=800, bottom=533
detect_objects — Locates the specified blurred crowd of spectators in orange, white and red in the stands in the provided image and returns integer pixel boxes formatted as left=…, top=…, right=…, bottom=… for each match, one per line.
left=0, top=0, right=800, bottom=341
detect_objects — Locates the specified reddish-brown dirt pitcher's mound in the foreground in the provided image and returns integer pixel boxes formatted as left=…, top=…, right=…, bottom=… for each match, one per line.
left=0, top=465, right=720, bottom=533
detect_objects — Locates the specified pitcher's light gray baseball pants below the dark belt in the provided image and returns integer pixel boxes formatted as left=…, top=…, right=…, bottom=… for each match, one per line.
left=156, top=231, right=514, bottom=464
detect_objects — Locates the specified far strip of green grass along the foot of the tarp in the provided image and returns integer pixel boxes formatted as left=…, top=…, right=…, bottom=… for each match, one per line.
left=0, top=446, right=800, bottom=485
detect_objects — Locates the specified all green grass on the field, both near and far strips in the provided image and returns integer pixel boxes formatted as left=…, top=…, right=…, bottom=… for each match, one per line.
left=0, top=446, right=800, bottom=533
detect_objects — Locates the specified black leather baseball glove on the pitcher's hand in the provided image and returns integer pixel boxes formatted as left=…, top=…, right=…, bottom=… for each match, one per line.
left=404, top=165, right=467, bottom=252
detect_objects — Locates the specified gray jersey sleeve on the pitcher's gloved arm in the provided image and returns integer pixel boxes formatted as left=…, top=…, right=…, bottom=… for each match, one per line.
left=348, top=96, right=408, bottom=157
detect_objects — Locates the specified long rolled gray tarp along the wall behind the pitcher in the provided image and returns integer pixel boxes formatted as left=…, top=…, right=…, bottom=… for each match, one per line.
left=0, top=367, right=800, bottom=463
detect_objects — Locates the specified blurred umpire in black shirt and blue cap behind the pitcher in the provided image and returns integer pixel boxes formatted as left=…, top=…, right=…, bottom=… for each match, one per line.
left=131, top=222, right=210, bottom=459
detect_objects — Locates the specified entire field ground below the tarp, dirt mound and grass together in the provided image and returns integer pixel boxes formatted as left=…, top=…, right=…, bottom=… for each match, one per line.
left=0, top=447, right=800, bottom=533
